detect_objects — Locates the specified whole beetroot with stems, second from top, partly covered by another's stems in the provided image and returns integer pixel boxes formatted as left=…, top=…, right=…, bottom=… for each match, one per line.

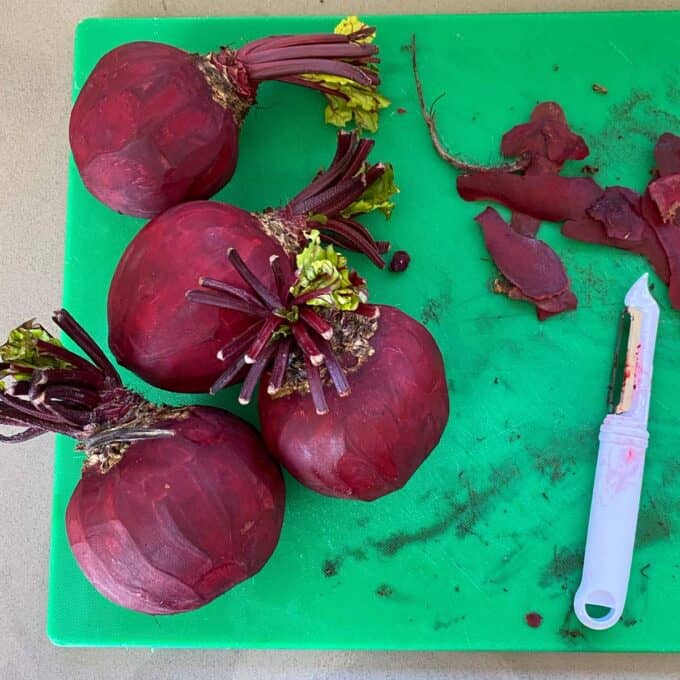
left=108, top=132, right=397, bottom=392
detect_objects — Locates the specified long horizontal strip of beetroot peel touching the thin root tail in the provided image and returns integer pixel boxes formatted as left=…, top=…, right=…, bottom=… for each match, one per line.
left=456, top=170, right=602, bottom=222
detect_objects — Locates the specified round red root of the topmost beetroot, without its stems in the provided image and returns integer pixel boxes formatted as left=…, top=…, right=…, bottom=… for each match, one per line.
left=69, top=42, right=239, bottom=217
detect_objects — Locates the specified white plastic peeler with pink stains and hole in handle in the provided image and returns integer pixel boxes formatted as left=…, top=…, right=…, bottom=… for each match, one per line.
left=574, top=274, right=659, bottom=630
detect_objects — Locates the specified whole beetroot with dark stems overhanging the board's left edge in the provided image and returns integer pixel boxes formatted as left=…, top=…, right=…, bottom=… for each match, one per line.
left=0, top=310, right=285, bottom=614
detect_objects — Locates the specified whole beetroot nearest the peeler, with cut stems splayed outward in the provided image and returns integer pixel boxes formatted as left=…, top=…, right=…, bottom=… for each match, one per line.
left=190, top=233, right=449, bottom=500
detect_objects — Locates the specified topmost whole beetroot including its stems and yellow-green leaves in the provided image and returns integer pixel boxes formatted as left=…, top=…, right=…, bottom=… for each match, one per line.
left=69, top=17, right=389, bottom=217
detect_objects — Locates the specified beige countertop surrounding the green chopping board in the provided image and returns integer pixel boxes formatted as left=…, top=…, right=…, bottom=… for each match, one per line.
left=0, top=0, right=680, bottom=680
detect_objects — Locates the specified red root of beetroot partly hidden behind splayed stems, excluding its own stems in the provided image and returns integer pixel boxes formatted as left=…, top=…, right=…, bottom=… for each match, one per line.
left=108, top=201, right=284, bottom=392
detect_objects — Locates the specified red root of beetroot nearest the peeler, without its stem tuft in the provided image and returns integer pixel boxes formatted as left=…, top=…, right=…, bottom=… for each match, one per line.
left=259, top=305, right=449, bottom=501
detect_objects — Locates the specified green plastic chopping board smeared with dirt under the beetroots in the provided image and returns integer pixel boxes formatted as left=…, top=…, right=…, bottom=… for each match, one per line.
left=47, top=12, right=680, bottom=651
